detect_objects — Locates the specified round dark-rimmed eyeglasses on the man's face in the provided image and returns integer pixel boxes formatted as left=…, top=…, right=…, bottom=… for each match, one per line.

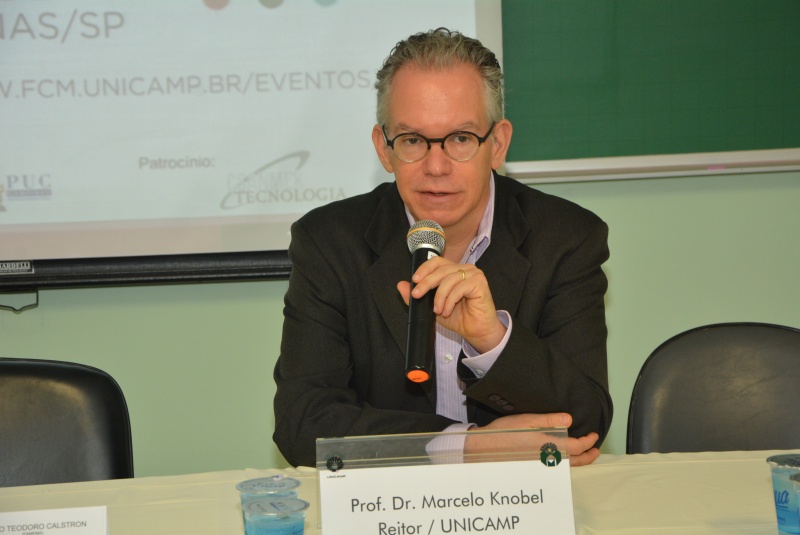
left=381, top=123, right=495, bottom=163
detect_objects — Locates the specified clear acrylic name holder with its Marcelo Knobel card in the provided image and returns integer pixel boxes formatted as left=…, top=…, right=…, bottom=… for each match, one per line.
left=317, top=428, right=575, bottom=535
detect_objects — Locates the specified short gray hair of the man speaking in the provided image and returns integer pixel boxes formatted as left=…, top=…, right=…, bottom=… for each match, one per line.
left=375, top=28, right=503, bottom=126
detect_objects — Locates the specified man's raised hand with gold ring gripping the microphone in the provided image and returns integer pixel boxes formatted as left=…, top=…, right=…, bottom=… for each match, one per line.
left=397, top=257, right=506, bottom=353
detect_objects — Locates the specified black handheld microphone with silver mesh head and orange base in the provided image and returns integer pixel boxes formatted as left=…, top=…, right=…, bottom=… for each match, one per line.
left=405, top=219, right=444, bottom=383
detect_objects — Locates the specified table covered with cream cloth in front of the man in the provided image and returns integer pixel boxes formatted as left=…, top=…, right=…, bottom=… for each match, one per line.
left=0, top=451, right=787, bottom=535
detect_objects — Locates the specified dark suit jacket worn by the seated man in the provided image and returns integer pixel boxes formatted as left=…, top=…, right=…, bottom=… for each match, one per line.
left=273, top=175, right=612, bottom=466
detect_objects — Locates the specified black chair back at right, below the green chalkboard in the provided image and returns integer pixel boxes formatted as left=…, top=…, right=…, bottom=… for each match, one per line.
left=626, top=323, right=800, bottom=453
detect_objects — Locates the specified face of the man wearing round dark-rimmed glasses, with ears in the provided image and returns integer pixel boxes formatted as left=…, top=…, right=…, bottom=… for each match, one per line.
left=372, top=64, right=511, bottom=240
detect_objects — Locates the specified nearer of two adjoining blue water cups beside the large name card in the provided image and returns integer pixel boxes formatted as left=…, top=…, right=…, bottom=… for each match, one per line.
left=244, top=498, right=308, bottom=535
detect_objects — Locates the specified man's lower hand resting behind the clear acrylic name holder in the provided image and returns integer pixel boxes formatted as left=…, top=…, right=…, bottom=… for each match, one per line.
left=464, top=412, right=600, bottom=466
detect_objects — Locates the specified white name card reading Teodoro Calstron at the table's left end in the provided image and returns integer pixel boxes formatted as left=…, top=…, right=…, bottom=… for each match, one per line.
left=0, top=506, right=108, bottom=535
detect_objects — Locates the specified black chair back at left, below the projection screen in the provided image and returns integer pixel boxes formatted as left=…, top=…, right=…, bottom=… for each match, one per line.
left=0, top=358, right=133, bottom=487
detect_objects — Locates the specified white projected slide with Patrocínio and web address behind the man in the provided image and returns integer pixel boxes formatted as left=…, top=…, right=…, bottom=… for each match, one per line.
left=0, top=0, right=476, bottom=260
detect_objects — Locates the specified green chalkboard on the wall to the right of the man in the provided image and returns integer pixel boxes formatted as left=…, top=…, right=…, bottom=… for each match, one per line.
left=502, top=0, right=800, bottom=161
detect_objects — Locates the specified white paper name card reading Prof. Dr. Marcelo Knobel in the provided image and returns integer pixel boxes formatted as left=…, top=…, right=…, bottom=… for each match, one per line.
left=319, top=432, right=575, bottom=535
